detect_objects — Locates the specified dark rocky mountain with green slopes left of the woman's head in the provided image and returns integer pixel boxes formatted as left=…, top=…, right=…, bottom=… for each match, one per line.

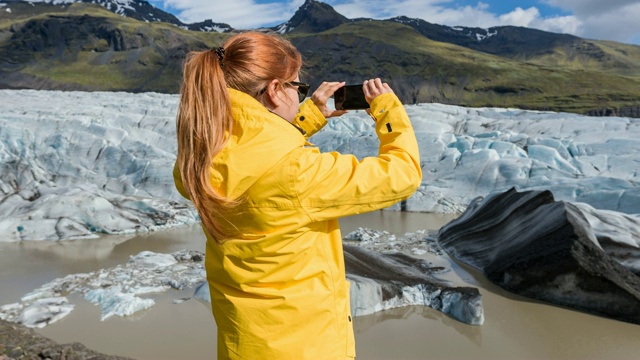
left=0, top=3, right=223, bottom=92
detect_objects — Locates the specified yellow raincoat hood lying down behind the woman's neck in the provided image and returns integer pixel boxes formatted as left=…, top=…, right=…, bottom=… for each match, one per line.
left=211, top=89, right=306, bottom=199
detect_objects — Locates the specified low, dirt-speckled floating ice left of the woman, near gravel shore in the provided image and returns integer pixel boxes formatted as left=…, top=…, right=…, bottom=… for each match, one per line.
left=0, top=250, right=205, bottom=327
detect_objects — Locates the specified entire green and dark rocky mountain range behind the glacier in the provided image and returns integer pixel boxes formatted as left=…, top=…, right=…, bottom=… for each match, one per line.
left=0, top=0, right=640, bottom=117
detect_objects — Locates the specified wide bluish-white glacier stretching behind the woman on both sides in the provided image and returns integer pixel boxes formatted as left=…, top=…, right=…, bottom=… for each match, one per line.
left=0, top=90, right=640, bottom=242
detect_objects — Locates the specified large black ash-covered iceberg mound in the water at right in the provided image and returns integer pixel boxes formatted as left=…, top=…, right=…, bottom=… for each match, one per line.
left=438, top=189, right=640, bottom=324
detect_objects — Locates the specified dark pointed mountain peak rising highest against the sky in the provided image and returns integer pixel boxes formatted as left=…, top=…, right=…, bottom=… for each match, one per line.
left=275, top=0, right=349, bottom=33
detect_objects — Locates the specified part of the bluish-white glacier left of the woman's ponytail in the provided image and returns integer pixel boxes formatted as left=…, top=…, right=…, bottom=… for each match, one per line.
left=0, top=91, right=198, bottom=241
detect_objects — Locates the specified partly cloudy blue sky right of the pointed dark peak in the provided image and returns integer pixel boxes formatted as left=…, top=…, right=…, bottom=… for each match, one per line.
left=327, top=0, right=640, bottom=43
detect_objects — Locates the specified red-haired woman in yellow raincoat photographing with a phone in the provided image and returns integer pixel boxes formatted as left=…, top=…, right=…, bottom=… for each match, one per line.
left=174, top=32, right=422, bottom=360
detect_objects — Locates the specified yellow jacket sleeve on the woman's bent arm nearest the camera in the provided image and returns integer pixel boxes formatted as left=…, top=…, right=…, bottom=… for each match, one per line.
left=293, top=94, right=422, bottom=221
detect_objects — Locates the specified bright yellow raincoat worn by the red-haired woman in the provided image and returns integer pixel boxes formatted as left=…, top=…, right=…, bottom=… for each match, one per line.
left=174, top=89, right=422, bottom=360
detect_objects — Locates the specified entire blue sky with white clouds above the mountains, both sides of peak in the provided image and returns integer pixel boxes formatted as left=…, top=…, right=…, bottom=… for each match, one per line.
left=150, top=0, right=640, bottom=44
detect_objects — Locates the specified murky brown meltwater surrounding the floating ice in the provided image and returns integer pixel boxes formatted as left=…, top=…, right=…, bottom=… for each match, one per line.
left=0, top=212, right=640, bottom=359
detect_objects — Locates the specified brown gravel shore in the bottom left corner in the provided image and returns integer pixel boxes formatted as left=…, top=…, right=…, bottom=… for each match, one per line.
left=0, top=320, right=131, bottom=360
